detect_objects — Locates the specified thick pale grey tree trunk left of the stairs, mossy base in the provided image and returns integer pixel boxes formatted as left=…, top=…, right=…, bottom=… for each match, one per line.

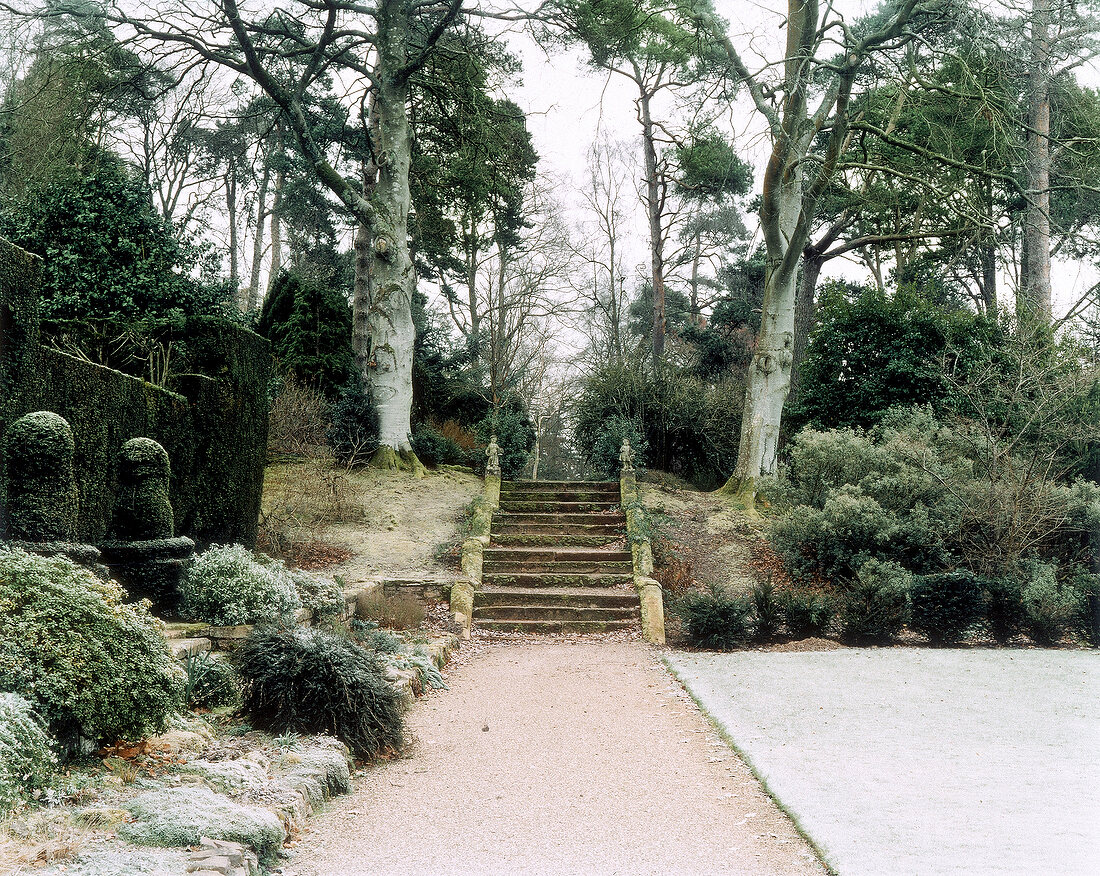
left=363, top=11, right=424, bottom=474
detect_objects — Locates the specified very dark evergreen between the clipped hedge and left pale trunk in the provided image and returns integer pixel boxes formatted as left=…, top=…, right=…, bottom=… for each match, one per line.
left=256, top=273, right=355, bottom=398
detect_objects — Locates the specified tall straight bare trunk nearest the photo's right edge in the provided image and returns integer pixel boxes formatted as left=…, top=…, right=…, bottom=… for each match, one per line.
left=1021, top=0, right=1051, bottom=324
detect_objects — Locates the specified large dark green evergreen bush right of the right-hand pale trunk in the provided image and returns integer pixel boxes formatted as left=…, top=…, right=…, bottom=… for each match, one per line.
left=789, top=287, right=996, bottom=429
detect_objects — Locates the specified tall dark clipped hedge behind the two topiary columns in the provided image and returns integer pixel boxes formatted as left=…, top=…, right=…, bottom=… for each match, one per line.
left=0, top=240, right=271, bottom=546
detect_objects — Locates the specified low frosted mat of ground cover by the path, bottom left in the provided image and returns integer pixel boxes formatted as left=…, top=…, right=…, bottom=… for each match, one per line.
left=119, top=788, right=286, bottom=863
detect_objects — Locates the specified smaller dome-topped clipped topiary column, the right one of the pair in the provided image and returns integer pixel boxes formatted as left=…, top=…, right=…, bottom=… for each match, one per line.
left=113, top=438, right=174, bottom=541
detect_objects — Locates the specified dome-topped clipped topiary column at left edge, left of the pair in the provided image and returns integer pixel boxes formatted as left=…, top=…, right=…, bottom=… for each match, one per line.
left=3, top=410, right=79, bottom=543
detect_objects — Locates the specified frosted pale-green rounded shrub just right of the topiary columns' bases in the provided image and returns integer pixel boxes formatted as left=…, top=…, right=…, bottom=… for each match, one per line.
left=184, top=545, right=301, bottom=626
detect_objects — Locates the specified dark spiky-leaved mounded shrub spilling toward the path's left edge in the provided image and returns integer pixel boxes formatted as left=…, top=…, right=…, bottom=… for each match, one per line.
left=235, top=626, right=404, bottom=758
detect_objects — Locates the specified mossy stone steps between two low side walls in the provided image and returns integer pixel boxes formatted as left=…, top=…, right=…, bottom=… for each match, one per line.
left=473, top=481, right=639, bottom=633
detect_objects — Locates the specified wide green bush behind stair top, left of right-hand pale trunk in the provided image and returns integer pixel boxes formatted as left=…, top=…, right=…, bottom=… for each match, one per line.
left=573, top=362, right=745, bottom=489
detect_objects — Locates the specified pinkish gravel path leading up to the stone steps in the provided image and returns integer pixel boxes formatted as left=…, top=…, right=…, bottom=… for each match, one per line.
left=284, top=639, right=824, bottom=876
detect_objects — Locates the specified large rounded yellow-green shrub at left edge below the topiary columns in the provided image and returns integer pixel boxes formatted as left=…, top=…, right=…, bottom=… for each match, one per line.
left=0, top=550, right=184, bottom=744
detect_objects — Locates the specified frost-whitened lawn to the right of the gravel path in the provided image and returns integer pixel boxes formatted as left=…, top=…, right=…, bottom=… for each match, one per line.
left=668, top=648, right=1100, bottom=876
